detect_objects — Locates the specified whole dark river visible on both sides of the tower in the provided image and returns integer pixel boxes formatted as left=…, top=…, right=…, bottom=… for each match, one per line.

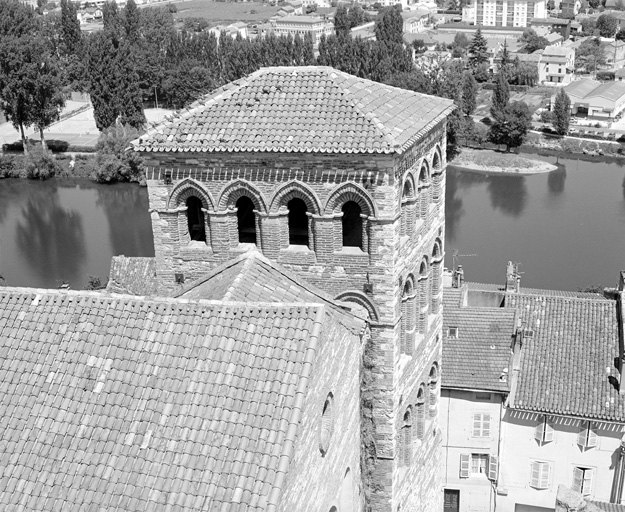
left=0, top=157, right=625, bottom=290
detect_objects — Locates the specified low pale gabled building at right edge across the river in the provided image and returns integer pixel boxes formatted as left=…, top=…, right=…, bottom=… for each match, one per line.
left=552, top=78, right=625, bottom=120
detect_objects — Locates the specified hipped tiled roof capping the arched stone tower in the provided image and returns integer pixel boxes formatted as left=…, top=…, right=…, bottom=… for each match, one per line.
left=133, top=66, right=454, bottom=153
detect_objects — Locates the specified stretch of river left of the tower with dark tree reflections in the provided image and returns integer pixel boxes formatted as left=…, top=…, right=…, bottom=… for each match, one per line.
left=0, top=179, right=154, bottom=289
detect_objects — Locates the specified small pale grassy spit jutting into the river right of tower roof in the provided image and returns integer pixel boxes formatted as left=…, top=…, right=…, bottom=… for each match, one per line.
left=450, top=148, right=557, bottom=176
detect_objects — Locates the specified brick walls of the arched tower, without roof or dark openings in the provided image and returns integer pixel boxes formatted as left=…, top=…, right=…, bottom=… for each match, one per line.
left=143, top=122, right=445, bottom=512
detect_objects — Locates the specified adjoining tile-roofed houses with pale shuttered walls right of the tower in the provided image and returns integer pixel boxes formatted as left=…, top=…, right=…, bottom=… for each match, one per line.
left=441, top=264, right=625, bottom=512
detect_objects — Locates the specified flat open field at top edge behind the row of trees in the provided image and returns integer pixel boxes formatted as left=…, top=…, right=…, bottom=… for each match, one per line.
left=169, top=0, right=280, bottom=25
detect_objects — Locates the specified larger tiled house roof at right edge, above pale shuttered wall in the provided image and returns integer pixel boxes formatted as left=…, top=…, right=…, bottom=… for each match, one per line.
left=506, top=293, right=625, bottom=421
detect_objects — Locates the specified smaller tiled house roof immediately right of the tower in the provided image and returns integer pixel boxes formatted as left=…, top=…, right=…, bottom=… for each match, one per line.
left=442, top=306, right=515, bottom=392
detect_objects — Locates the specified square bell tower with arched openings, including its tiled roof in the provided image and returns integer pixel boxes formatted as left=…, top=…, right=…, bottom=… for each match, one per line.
left=135, top=67, right=453, bottom=511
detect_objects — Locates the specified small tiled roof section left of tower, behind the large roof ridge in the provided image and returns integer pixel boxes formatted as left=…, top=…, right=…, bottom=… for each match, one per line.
left=106, top=256, right=158, bottom=295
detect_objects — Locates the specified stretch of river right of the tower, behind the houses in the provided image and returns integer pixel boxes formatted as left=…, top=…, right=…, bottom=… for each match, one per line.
left=445, top=156, right=625, bottom=290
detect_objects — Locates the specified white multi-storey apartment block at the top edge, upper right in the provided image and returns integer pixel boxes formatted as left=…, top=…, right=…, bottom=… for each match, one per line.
left=462, top=0, right=547, bottom=27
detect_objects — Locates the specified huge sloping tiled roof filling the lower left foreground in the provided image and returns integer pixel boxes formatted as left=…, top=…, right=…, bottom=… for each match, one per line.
left=0, top=288, right=328, bottom=511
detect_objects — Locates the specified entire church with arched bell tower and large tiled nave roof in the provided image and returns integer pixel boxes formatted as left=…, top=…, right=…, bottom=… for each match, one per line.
left=0, top=66, right=454, bottom=512
